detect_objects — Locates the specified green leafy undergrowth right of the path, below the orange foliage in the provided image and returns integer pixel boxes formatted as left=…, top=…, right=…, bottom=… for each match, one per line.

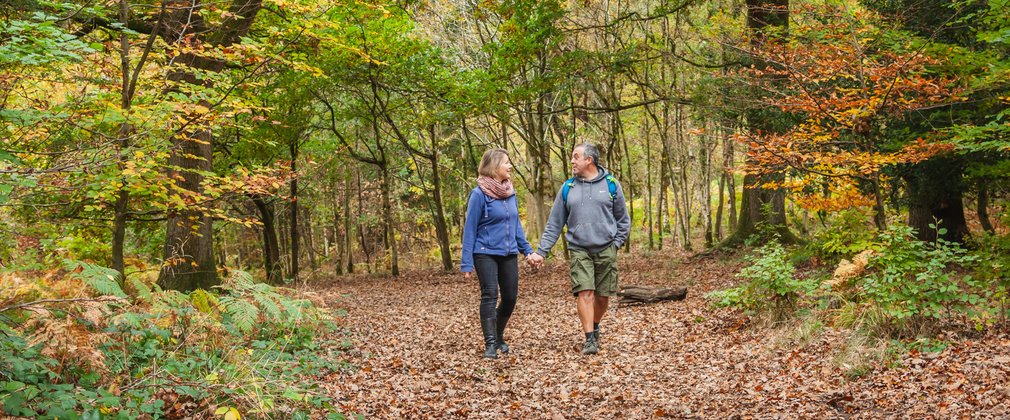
left=707, top=220, right=1010, bottom=377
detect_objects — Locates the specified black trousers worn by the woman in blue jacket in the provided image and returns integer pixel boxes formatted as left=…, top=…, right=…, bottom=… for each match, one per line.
left=474, top=253, right=519, bottom=319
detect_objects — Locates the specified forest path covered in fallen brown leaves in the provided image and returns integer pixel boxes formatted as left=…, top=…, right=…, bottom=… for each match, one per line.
left=318, top=254, right=1010, bottom=418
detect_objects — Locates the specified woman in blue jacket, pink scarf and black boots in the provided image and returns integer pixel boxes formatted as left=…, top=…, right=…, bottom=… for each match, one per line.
left=460, top=148, right=533, bottom=358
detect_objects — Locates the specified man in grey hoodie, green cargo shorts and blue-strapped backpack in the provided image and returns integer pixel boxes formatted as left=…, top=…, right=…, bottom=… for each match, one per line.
left=529, top=143, right=631, bottom=354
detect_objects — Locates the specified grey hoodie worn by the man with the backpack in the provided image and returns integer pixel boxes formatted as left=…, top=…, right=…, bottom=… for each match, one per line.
left=536, top=166, right=631, bottom=256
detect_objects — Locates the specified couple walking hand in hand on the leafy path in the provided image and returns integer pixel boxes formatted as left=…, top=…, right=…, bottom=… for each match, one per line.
left=461, top=143, right=631, bottom=358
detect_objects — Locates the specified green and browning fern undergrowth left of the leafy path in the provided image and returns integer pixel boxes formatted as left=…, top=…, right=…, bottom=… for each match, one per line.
left=0, top=261, right=351, bottom=419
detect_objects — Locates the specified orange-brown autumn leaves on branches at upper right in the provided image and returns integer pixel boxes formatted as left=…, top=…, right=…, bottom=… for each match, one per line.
left=738, top=6, right=964, bottom=216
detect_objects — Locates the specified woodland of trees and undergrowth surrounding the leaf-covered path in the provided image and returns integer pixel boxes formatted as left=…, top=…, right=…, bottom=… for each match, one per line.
left=0, top=0, right=1010, bottom=417
